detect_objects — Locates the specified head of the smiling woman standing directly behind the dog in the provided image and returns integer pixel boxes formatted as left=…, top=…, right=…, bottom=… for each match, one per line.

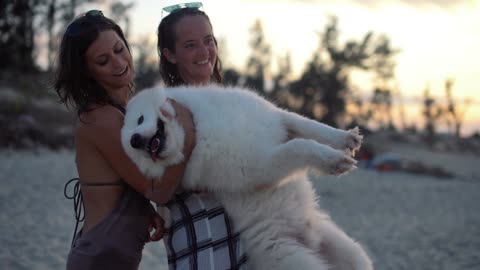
left=157, top=5, right=222, bottom=86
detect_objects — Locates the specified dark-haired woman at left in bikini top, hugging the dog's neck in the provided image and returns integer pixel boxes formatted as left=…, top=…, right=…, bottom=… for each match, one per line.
left=51, top=11, right=193, bottom=270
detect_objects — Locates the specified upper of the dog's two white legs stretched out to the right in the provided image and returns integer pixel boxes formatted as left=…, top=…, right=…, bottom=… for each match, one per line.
left=282, top=111, right=363, bottom=152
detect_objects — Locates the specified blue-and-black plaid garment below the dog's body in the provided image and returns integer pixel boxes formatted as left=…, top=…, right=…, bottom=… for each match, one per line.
left=164, top=192, right=247, bottom=270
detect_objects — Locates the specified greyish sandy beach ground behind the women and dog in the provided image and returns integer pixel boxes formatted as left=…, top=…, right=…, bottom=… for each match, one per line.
left=0, top=141, right=480, bottom=270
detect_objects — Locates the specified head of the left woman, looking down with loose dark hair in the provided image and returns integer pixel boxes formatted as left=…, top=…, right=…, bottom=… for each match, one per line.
left=55, top=11, right=134, bottom=114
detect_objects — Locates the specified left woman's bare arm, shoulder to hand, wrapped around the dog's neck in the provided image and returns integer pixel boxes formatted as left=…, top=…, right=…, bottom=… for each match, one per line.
left=77, top=103, right=195, bottom=204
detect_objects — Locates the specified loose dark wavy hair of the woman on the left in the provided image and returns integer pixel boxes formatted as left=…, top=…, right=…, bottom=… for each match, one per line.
left=54, top=10, right=133, bottom=115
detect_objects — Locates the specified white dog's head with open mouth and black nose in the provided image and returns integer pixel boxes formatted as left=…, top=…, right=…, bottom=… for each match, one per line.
left=122, top=88, right=185, bottom=176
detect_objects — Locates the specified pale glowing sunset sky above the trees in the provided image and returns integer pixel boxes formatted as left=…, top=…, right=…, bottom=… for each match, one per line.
left=71, top=0, right=480, bottom=134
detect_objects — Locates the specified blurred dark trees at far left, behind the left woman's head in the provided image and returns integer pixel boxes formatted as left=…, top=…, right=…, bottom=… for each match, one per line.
left=0, top=0, right=133, bottom=72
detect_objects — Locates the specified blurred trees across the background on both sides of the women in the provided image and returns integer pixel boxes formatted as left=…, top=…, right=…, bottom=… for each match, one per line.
left=0, top=0, right=472, bottom=138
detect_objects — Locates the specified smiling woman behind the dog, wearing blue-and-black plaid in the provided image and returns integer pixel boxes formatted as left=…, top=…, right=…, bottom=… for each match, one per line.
left=157, top=7, right=247, bottom=270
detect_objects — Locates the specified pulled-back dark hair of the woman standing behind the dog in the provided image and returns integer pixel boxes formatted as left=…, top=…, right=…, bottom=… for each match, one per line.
left=157, top=7, right=222, bottom=86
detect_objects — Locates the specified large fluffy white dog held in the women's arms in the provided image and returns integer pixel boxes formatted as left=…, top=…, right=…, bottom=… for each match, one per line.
left=122, top=85, right=373, bottom=270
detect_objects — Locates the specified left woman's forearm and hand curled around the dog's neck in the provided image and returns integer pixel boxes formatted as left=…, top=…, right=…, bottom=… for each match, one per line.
left=145, top=100, right=195, bottom=204
